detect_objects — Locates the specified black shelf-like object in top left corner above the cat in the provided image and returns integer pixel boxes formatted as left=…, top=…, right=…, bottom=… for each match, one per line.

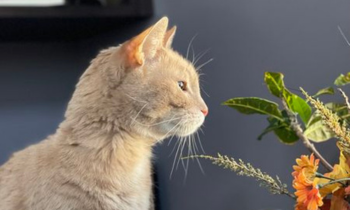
left=0, top=0, right=153, bottom=42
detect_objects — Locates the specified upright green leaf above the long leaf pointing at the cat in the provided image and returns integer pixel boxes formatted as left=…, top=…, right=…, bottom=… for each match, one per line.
left=264, top=72, right=285, bottom=98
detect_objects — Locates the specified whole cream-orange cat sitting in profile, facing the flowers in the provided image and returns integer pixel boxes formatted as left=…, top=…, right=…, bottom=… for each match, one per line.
left=0, top=17, right=208, bottom=210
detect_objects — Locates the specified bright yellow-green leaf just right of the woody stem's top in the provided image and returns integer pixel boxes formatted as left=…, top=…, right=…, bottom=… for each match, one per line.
left=283, top=90, right=312, bottom=124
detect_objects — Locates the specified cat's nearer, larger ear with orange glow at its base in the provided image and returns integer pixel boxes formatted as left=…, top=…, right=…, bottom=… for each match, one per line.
left=126, top=17, right=169, bottom=66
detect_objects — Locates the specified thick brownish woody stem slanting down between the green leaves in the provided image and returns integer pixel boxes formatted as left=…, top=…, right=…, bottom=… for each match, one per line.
left=282, top=99, right=333, bottom=171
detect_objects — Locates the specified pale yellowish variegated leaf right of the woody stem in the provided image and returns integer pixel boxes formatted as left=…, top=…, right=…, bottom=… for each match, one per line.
left=304, top=117, right=334, bottom=142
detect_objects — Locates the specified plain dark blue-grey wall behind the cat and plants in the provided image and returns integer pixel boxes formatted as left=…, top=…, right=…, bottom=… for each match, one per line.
left=0, top=0, right=350, bottom=210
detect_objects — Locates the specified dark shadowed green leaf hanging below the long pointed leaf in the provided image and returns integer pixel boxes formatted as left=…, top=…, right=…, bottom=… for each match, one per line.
left=268, top=118, right=299, bottom=144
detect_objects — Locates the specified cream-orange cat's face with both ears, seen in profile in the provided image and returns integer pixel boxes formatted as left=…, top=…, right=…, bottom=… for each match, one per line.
left=122, top=17, right=208, bottom=138
